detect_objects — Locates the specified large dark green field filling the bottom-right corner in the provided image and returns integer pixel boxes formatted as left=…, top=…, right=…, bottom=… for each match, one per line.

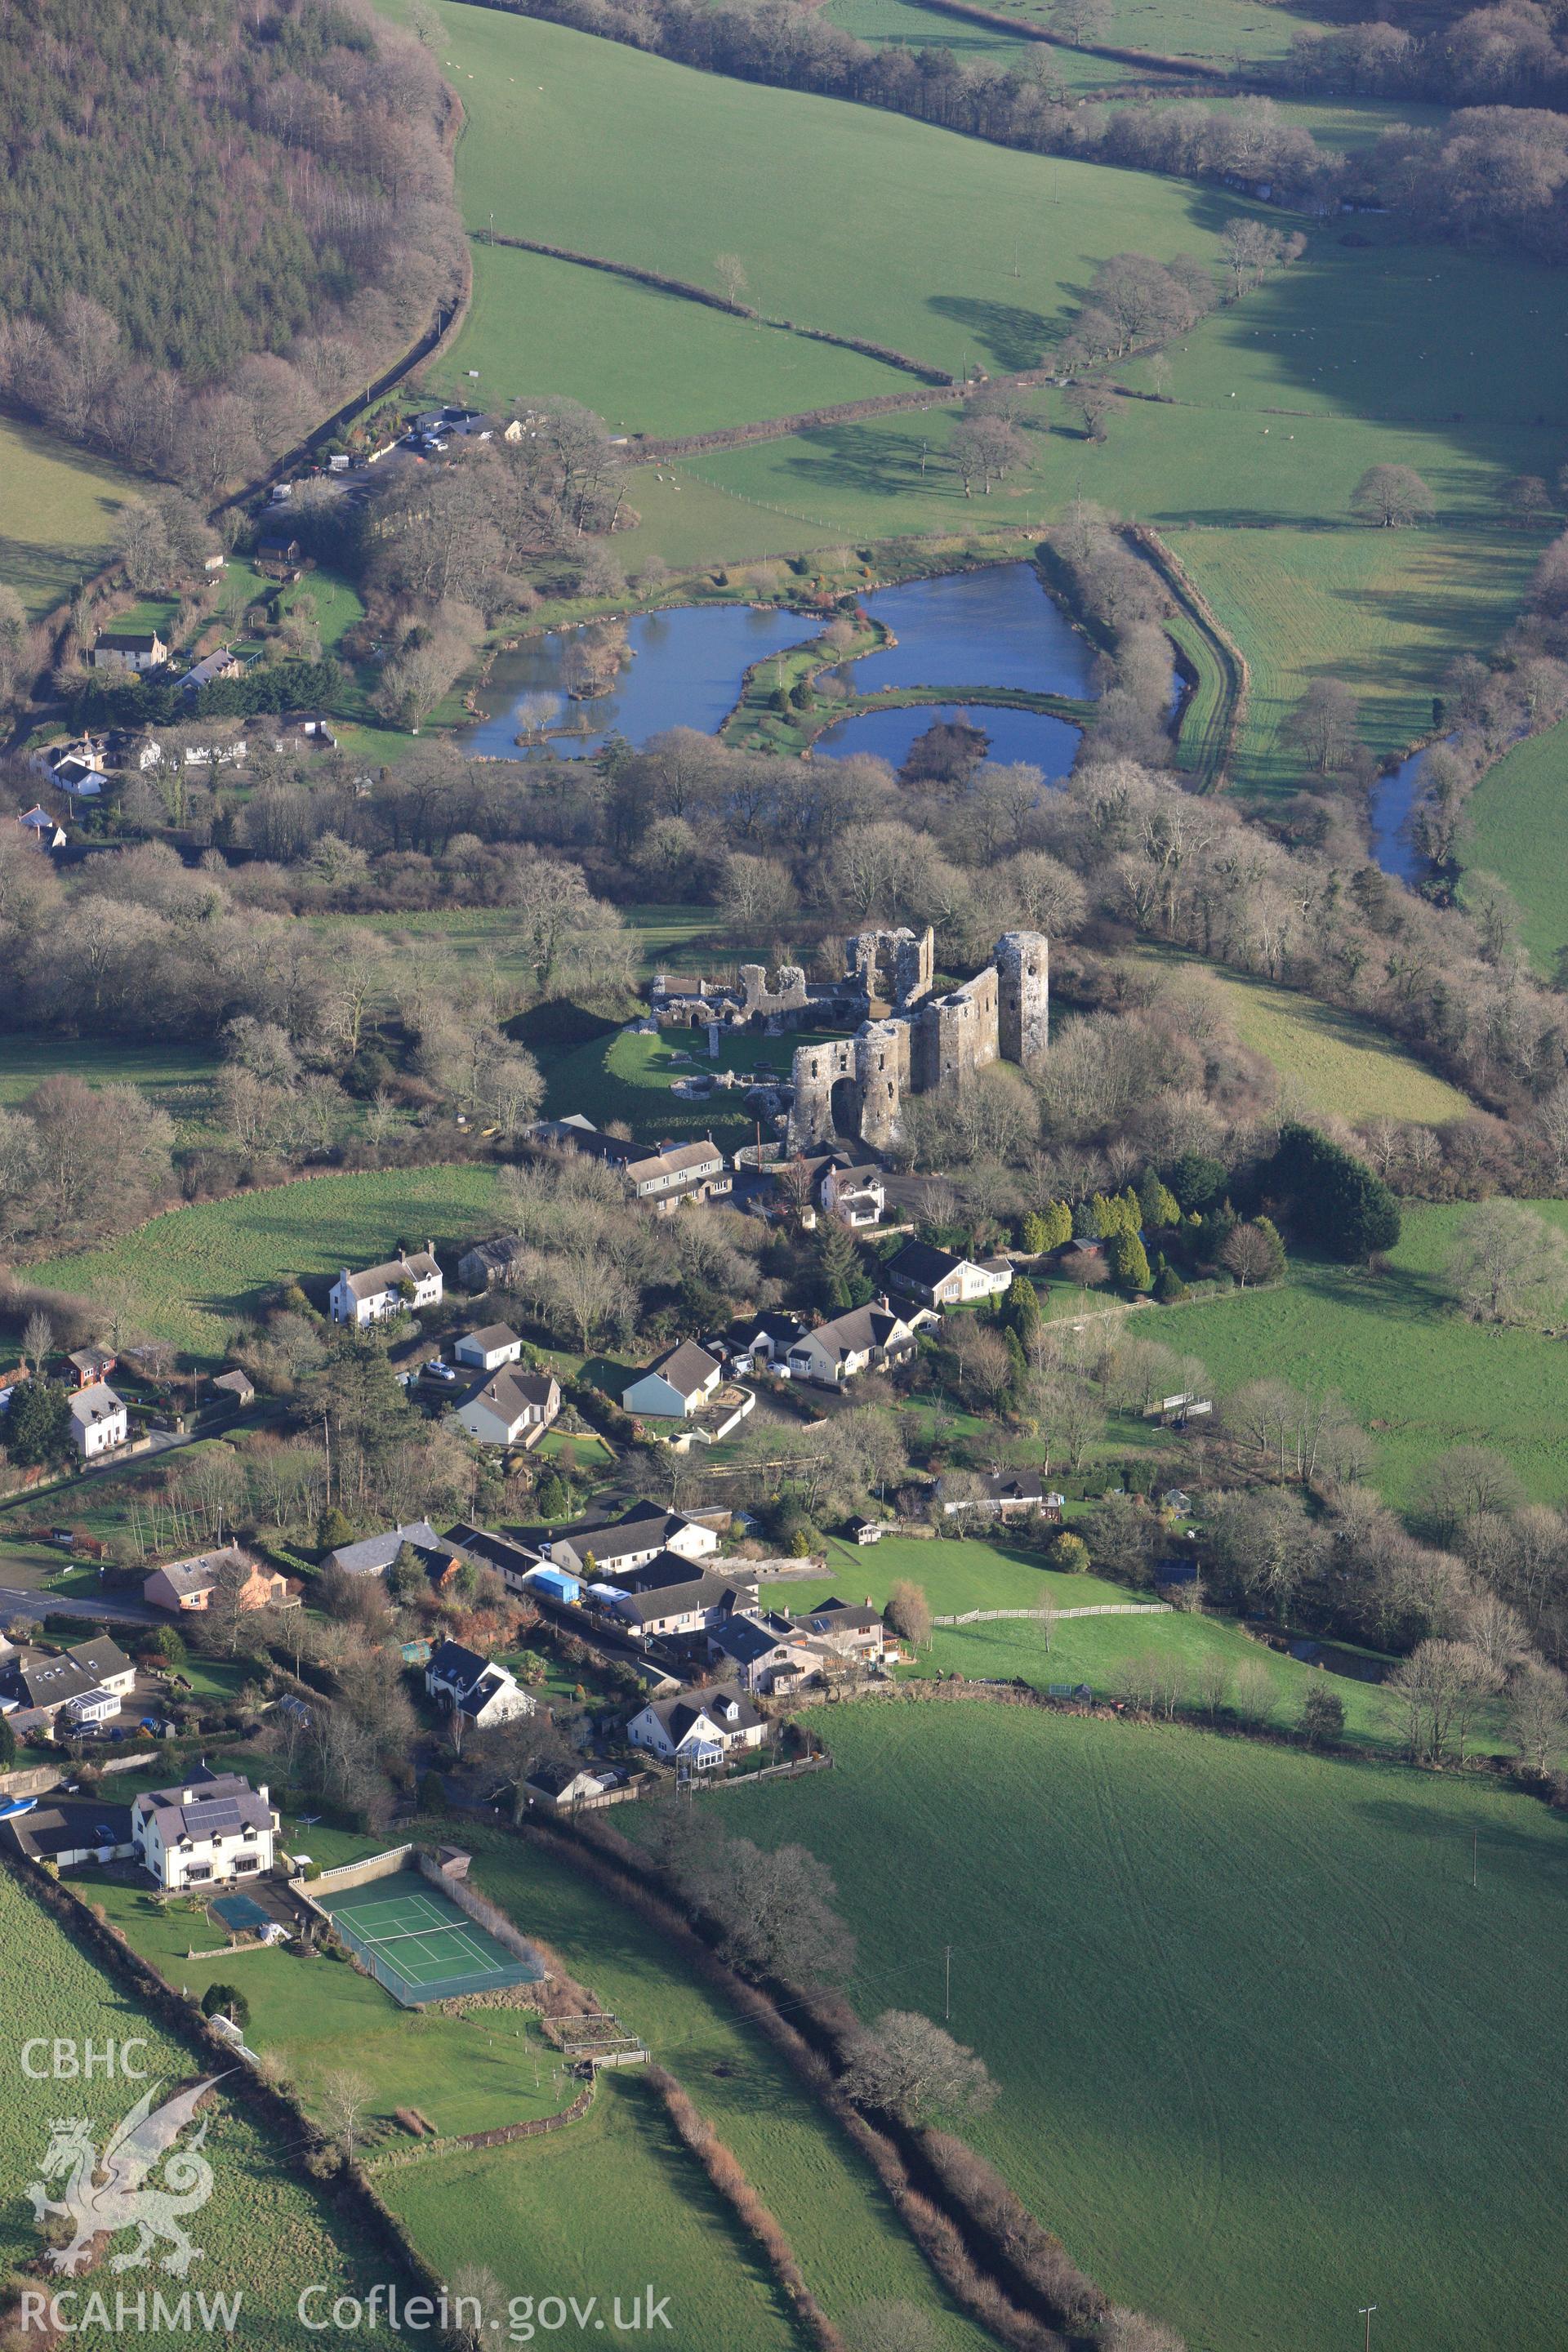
left=746, top=1703, right=1568, bottom=2352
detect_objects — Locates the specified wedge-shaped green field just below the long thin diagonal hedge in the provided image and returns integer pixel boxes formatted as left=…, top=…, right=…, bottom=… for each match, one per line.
left=433, top=245, right=912, bottom=433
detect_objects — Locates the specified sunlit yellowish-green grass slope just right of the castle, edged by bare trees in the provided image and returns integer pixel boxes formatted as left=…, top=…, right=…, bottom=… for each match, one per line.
left=1145, top=948, right=1469, bottom=1125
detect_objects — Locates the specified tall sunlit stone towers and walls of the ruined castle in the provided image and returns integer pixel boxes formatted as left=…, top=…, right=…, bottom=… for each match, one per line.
left=781, top=929, right=1051, bottom=1152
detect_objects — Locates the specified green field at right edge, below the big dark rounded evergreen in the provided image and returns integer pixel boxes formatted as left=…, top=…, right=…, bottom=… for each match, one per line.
left=1170, top=1200, right=1568, bottom=1503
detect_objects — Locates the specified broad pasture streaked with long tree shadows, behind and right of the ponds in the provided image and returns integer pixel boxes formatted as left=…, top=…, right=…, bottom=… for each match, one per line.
left=611, top=212, right=1568, bottom=791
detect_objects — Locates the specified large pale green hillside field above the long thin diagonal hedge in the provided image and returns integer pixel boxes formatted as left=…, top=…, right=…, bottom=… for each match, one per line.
left=408, top=0, right=1246, bottom=376
